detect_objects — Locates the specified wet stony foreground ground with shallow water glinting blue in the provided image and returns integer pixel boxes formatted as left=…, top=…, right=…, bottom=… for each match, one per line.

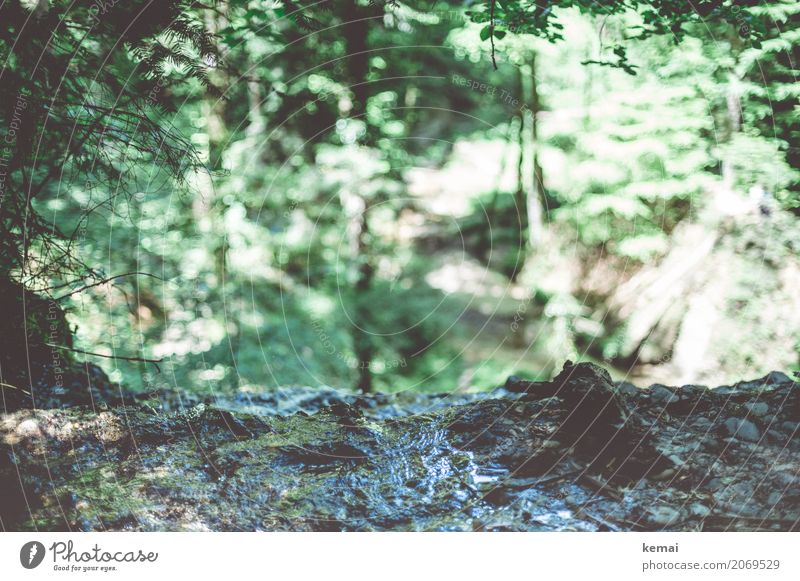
left=0, top=363, right=800, bottom=531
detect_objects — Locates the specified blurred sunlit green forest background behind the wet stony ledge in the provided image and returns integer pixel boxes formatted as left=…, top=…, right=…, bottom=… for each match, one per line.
left=6, top=1, right=800, bottom=393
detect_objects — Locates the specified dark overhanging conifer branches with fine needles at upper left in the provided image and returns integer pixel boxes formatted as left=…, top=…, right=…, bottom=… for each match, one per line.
left=0, top=0, right=215, bottom=285
